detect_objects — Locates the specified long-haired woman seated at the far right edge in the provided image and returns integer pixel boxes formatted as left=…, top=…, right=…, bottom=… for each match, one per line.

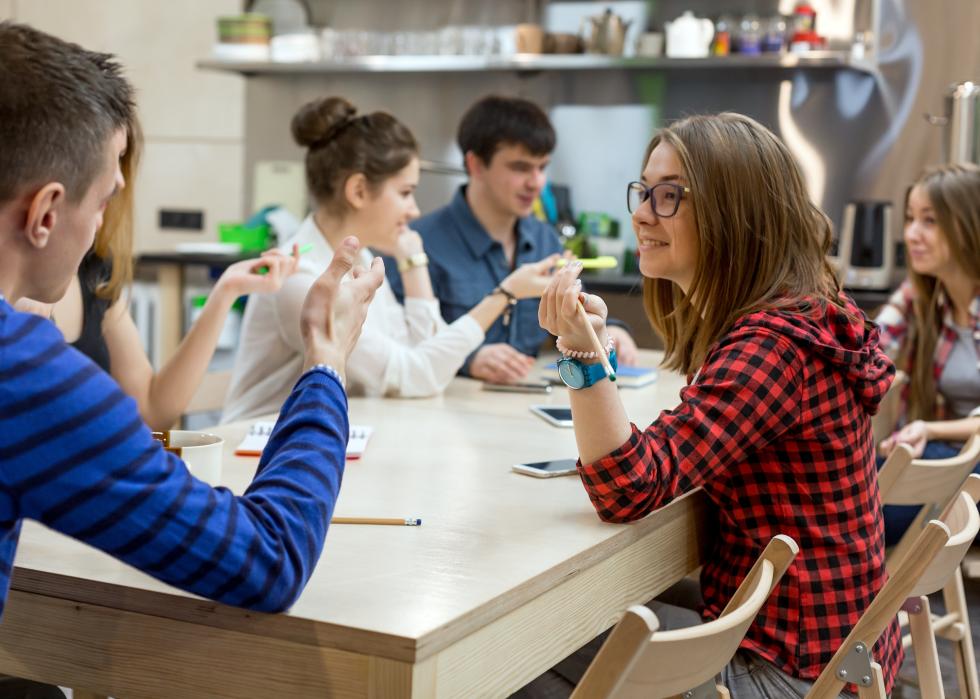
left=875, top=164, right=980, bottom=544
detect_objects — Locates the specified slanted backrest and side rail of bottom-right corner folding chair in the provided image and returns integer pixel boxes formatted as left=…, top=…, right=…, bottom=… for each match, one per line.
left=807, top=475, right=980, bottom=699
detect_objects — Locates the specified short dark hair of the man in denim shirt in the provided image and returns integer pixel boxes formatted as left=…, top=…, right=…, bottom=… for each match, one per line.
left=456, top=95, right=555, bottom=170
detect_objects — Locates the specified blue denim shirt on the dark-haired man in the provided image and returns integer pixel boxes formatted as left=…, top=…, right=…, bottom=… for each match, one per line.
left=385, top=185, right=562, bottom=375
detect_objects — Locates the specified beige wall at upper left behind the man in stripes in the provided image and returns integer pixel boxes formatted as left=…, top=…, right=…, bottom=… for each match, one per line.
left=10, top=0, right=246, bottom=251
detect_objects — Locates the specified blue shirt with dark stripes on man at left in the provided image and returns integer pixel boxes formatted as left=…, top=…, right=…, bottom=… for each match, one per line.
left=0, top=297, right=349, bottom=614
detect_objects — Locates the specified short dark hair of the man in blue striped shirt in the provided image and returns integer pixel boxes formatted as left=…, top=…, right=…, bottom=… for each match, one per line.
left=0, top=22, right=134, bottom=202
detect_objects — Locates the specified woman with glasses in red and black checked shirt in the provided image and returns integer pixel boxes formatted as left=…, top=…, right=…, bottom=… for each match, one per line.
left=539, top=114, right=902, bottom=699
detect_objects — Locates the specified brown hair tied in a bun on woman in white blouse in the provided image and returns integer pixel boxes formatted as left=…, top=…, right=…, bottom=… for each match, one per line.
left=291, top=97, right=419, bottom=214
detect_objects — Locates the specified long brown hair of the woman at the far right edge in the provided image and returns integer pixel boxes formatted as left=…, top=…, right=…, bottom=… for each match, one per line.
left=899, top=163, right=980, bottom=420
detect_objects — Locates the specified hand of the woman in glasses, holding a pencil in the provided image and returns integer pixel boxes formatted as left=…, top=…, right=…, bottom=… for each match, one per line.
left=538, top=262, right=608, bottom=352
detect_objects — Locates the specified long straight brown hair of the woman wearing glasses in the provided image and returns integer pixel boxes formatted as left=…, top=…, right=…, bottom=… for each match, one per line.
left=643, top=112, right=840, bottom=374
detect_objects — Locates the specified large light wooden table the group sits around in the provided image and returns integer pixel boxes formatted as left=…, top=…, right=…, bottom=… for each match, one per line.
left=0, top=356, right=708, bottom=699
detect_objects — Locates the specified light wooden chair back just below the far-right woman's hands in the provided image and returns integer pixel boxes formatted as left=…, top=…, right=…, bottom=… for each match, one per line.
left=878, top=431, right=980, bottom=571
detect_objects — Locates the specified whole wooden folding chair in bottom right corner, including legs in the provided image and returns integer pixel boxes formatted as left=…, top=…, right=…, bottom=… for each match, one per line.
left=807, top=475, right=980, bottom=699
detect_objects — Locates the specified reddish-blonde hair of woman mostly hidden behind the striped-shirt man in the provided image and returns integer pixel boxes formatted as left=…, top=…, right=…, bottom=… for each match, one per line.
left=92, top=114, right=143, bottom=304
